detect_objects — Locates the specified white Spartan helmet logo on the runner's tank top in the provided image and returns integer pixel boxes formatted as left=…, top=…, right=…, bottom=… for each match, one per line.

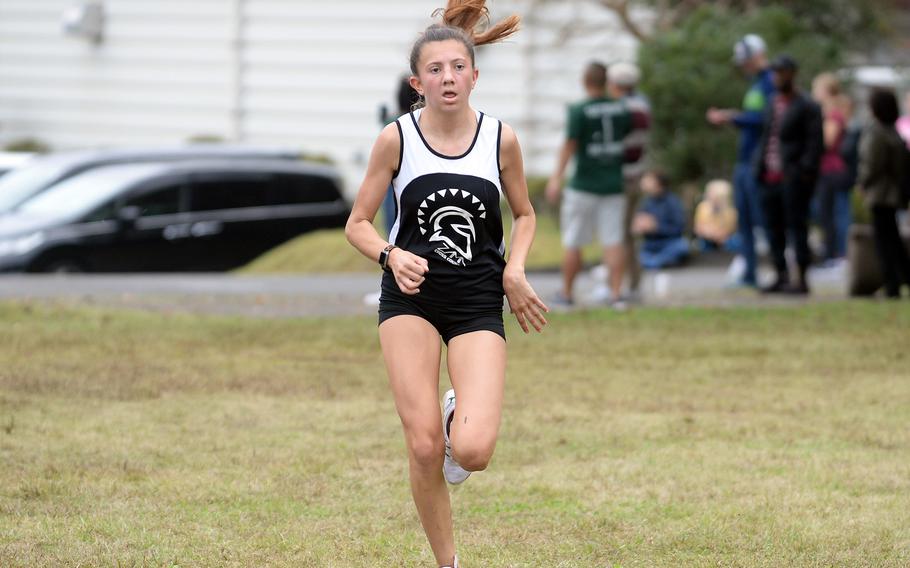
left=417, top=189, right=487, bottom=266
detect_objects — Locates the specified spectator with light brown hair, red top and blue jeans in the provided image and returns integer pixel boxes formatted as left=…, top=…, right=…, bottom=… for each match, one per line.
left=812, top=73, right=852, bottom=266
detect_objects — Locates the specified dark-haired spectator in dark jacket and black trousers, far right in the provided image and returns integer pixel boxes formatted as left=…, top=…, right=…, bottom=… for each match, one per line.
left=858, top=89, right=910, bottom=298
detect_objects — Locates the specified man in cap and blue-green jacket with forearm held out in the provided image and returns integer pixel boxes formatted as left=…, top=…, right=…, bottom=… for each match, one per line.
left=706, top=34, right=774, bottom=287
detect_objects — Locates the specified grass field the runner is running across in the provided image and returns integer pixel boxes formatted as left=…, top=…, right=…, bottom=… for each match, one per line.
left=0, top=302, right=910, bottom=568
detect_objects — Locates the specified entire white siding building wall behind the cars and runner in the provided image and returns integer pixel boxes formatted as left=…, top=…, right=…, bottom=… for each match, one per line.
left=0, top=0, right=635, bottom=193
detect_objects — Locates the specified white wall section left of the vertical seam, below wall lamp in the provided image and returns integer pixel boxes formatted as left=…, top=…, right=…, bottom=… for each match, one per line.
left=0, top=0, right=230, bottom=148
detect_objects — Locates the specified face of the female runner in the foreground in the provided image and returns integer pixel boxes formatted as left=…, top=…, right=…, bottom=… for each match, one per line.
left=411, top=39, right=477, bottom=110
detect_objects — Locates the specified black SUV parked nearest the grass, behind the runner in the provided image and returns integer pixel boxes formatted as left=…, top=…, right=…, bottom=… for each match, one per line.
left=0, top=159, right=350, bottom=272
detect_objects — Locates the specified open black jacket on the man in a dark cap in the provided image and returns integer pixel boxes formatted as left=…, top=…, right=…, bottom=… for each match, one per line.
left=755, top=91, right=825, bottom=191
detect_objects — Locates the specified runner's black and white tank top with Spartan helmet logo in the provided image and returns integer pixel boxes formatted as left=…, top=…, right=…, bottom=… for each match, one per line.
left=383, top=110, right=505, bottom=306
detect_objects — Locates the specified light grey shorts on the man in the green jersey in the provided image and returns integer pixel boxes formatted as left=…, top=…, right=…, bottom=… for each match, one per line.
left=559, top=187, right=626, bottom=249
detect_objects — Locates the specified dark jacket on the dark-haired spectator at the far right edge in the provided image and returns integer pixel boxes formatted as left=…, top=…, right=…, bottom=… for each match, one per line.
left=857, top=120, right=908, bottom=209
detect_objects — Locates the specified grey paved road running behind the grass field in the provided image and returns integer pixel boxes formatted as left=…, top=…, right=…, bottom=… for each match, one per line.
left=0, top=267, right=844, bottom=317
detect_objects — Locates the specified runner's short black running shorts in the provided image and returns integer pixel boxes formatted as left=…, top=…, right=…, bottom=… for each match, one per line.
left=379, top=287, right=506, bottom=345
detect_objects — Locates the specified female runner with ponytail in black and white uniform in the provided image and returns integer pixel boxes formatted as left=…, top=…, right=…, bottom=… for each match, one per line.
left=345, top=0, right=548, bottom=567
